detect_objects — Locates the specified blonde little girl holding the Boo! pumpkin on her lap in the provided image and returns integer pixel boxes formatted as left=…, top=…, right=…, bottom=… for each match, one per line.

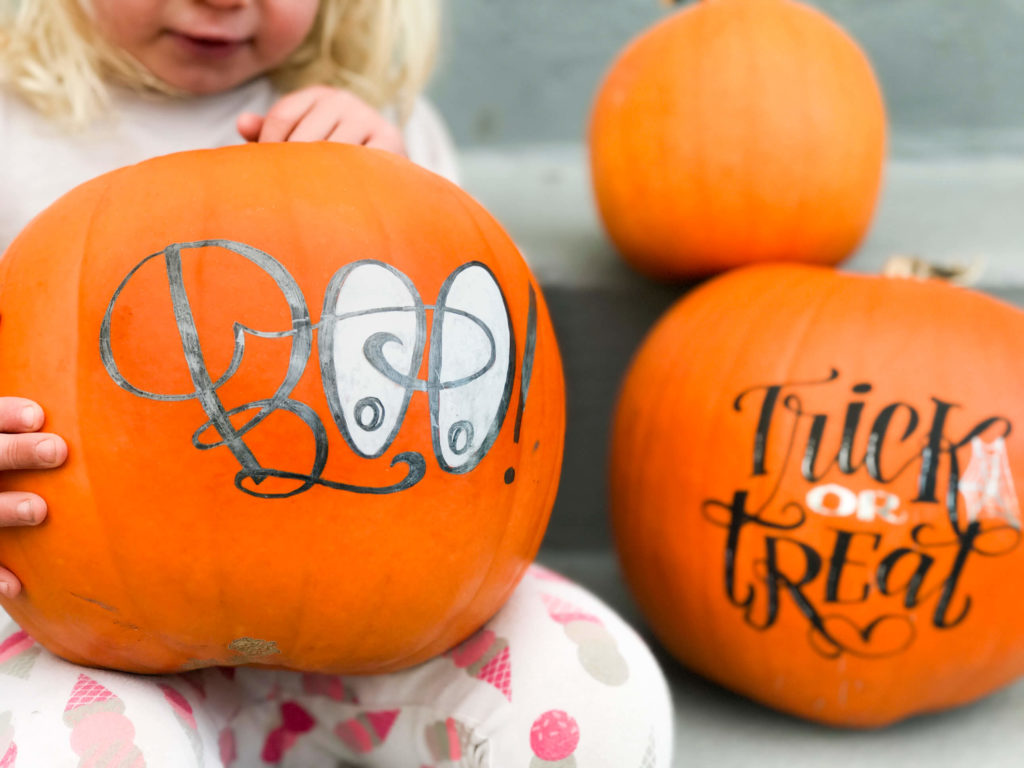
left=0, top=0, right=672, bottom=768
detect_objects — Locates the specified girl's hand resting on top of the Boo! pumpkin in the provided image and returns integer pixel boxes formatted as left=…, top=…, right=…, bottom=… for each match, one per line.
left=237, top=85, right=406, bottom=155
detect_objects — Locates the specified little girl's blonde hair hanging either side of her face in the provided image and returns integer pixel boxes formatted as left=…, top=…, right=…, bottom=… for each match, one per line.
left=0, top=0, right=440, bottom=127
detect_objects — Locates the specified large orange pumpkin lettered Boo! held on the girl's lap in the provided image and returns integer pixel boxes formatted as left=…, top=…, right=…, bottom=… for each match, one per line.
left=0, top=144, right=564, bottom=673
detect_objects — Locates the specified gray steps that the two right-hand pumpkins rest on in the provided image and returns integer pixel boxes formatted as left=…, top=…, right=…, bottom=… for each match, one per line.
left=464, top=145, right=1024, bottom=768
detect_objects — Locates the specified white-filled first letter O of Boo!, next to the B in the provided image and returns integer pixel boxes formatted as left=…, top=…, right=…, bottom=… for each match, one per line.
left=317, top=260, right=426, bottom=459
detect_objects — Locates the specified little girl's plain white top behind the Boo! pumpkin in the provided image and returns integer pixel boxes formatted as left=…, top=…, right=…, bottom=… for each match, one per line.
left=0, top=79, right=457, bottom=253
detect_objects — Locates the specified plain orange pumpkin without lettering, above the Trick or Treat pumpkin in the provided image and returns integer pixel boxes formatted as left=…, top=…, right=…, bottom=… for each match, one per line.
left=590, top=0, right=886, bottom=279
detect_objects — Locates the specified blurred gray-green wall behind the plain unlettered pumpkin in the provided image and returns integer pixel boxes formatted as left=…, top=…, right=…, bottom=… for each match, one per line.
left=431, top=0, right=1024, bottom=156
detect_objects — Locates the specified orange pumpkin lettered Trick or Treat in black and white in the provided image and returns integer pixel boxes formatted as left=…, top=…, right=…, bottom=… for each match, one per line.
left=611, top=265, right=1024, bottom=726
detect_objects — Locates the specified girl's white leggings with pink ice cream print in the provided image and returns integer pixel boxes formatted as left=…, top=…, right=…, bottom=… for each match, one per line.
left=0, top=565, right=672, bottom=768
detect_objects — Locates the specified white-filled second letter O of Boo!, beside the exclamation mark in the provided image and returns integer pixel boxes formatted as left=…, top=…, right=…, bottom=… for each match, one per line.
left=428, top=262, right=515, bottom=473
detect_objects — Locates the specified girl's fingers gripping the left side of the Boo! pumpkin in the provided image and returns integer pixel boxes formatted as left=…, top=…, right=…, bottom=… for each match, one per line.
left=0, top=397, right=68, bottom=597
